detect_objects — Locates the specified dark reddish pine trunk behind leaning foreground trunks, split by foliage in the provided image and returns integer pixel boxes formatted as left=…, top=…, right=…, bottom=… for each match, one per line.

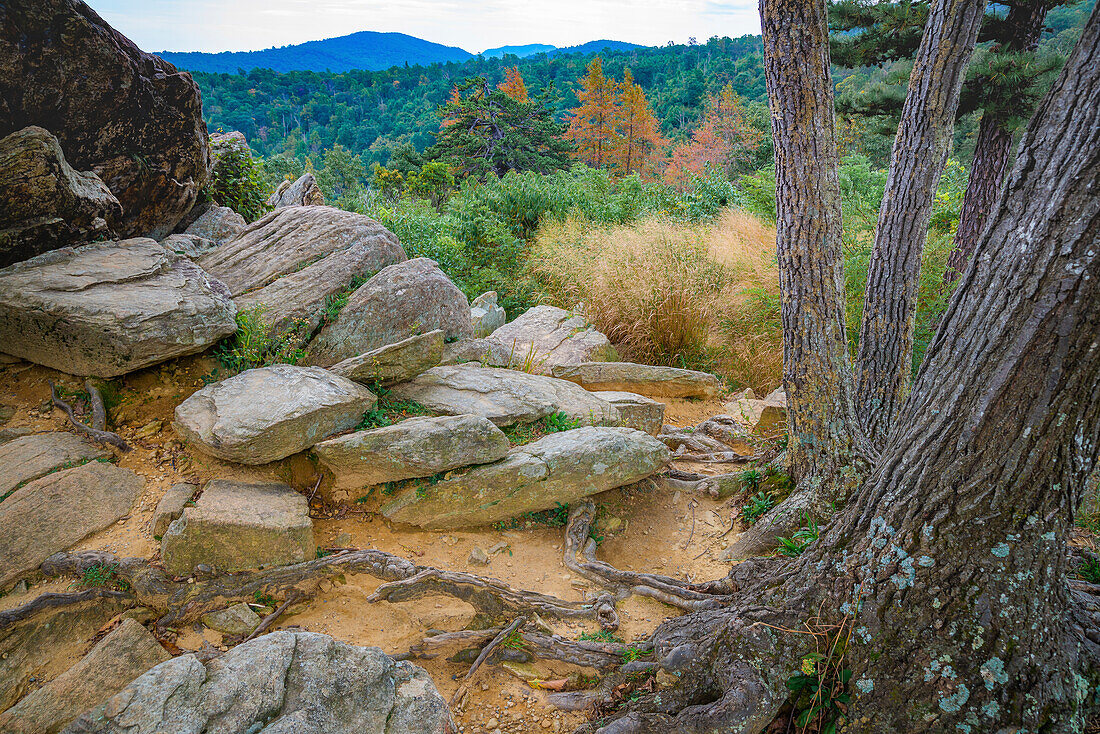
left=944, top=2, right=1047, bottom=284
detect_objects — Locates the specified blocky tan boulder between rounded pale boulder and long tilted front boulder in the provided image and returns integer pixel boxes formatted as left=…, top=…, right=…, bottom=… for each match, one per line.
left=314, top=415, right=509, bottom=499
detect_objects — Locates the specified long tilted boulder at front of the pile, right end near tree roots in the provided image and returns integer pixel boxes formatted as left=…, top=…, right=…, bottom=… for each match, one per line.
left=382, top=427, right=670, bottom=529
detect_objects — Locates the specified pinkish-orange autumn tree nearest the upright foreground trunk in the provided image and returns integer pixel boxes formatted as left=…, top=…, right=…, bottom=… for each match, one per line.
left=664, top=84, right=763, bottom=186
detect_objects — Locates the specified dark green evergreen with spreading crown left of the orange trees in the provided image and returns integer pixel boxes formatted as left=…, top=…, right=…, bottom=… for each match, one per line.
left=424, top=77, right=570, bottom=178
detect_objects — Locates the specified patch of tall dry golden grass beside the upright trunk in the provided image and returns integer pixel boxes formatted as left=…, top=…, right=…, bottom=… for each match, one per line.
left=528, top=210, right=782, bottom=392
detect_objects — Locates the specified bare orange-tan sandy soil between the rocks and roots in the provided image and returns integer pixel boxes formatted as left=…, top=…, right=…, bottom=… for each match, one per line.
left=0, top=357, right=752, bottom=733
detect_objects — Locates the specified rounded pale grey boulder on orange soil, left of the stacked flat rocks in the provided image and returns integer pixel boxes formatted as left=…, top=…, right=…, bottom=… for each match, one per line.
left=172, top=364, right=376, bottom=464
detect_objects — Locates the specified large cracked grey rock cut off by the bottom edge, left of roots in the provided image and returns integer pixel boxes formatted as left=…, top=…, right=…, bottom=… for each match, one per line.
left=66, top=632, right=455, bottom=734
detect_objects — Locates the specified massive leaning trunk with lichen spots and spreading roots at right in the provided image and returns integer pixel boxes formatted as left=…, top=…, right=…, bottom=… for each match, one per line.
left=603, top=4, right=1100, bottom=734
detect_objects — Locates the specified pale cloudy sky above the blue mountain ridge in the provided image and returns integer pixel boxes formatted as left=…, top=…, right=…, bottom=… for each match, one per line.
left=88, top=0, right=760, bottom=53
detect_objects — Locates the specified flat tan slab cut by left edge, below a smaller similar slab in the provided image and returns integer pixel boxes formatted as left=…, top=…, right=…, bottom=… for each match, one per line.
left=0, top=461, right=145, bottom=589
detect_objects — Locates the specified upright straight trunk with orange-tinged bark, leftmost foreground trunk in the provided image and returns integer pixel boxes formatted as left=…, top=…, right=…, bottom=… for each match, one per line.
left=736, top=0, right=873, bottom=556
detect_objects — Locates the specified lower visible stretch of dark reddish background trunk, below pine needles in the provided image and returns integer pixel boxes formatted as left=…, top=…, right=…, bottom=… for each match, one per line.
left=944, top=110, right=1012, bottom=284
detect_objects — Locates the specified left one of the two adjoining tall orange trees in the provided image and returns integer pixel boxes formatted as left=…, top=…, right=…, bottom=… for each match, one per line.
left=565, top=56, right=620, bottom=168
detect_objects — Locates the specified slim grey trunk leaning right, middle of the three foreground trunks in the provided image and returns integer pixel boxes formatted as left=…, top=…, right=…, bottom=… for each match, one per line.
left=856, top=0, right=986, bottom=448
